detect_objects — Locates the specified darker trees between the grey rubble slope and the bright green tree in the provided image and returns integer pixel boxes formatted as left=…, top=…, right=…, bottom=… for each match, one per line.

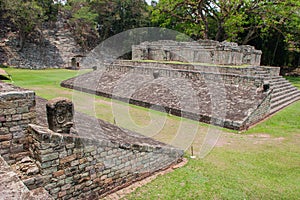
left=62, top=0, right=149, bottom=49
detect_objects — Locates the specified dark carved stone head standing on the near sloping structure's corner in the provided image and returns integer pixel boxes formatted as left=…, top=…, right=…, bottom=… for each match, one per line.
left=46, top=98, right=74, bottom=133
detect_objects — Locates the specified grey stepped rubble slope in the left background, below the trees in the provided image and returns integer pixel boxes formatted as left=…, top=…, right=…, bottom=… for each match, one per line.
left=0, top=17, right=84, bottom=69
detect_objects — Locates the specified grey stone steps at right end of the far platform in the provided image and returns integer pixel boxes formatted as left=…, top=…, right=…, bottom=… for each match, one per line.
left=256, top=67, right=300, bottom=114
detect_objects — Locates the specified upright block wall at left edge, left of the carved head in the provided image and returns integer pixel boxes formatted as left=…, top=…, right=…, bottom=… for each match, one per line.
left=0, top=82, right=35, bottom=164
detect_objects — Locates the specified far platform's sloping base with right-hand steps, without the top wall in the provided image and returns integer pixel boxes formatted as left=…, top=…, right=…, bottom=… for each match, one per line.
left=61, top=57, right=300, bottom=130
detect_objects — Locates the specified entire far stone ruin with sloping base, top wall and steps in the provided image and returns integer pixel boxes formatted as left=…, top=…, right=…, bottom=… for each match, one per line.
left=61, top=41, right=300, bottom=130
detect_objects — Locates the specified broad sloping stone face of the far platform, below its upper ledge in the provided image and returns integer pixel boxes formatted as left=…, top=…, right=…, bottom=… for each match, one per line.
left=62, top=64, right=270, bottom=129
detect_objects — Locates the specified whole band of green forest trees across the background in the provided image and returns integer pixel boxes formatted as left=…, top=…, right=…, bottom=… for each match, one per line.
left=0, top=0, right=300, bottom=69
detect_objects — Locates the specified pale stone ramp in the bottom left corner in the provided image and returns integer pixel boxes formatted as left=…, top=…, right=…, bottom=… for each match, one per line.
left=0, top=156, right=53, bottom=200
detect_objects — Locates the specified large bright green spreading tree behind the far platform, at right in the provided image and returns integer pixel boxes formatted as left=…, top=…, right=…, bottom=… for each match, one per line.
left=152, top=0, right=300, bottom=65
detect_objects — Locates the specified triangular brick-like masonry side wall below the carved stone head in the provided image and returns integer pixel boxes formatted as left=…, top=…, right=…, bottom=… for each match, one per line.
left=29, top=125, right=183, bottom=199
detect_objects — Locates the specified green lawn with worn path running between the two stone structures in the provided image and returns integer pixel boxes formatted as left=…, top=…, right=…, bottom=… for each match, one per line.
left=2, top=68, right=300, bottom=200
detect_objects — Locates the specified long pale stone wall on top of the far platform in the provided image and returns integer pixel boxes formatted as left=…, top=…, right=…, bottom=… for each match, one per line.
left=132, top=40, right=262, bottom=66
